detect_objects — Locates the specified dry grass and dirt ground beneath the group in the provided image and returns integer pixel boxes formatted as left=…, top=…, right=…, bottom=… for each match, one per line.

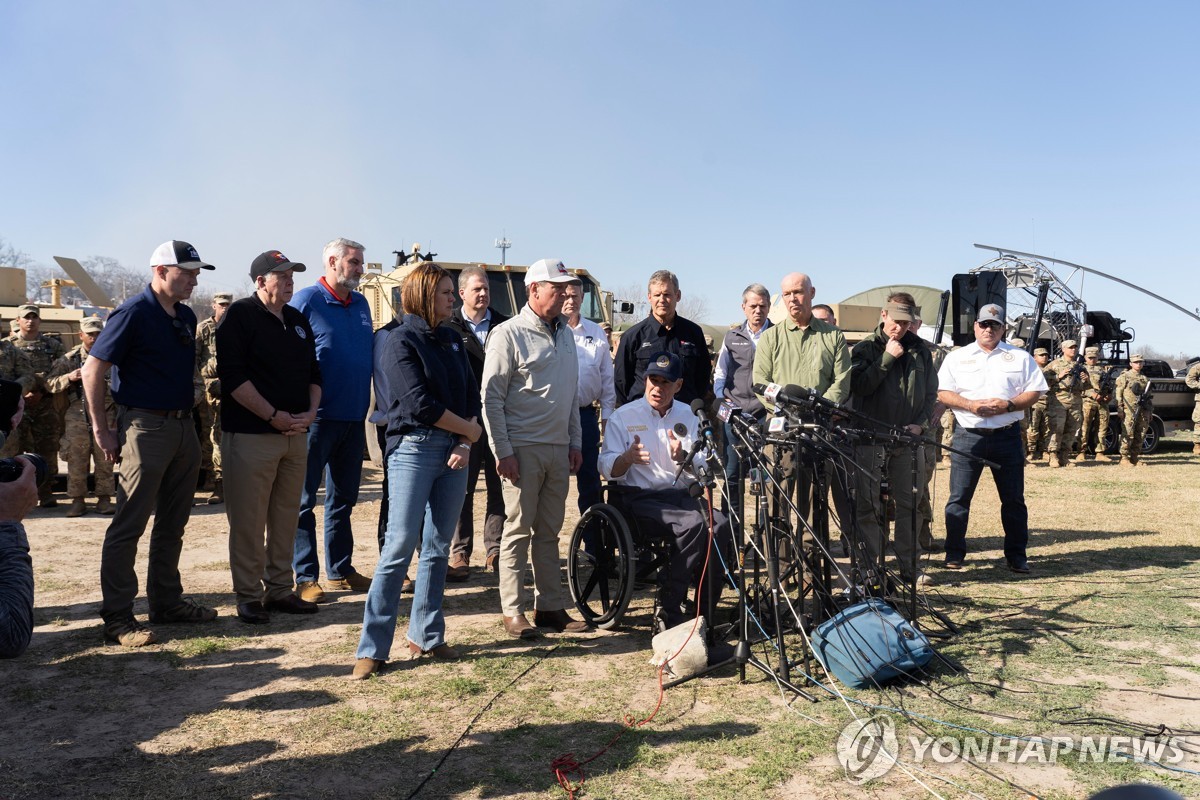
left=0, top=446, right=1200, bottom=799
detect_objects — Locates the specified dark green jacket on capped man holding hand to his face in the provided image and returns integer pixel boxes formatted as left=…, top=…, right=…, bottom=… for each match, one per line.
left=850, top=323, right=937, bottom=428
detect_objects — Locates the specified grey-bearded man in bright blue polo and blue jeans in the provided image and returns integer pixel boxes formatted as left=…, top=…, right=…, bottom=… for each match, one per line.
left=289, top=239, right=374, bottom=603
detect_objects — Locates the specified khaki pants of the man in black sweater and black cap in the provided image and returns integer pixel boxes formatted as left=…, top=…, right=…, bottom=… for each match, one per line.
left=221, top=431, right=308, bottom=603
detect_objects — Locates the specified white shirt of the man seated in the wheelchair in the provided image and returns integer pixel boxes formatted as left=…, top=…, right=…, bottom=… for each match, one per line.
left=600, top=397, right=704, bottom=489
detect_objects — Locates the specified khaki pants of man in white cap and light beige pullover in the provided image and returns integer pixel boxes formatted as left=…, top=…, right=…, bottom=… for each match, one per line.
left=499, top=444, right=570, bottom=616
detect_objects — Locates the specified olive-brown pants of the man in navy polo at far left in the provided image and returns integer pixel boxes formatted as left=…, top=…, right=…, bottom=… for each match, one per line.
left=100, top=407, right=200, bottom=622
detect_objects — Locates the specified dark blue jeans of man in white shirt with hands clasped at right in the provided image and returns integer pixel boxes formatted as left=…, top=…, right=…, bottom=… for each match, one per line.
left=946, top=425, right=1030, bottom=563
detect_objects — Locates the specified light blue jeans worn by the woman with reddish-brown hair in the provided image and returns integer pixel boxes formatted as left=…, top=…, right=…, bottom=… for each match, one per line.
left=358, top=428, right=467, bottom=661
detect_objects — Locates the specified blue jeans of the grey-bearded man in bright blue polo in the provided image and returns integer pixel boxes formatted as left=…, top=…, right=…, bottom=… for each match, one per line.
left=292, top=420, right=366, bottom=583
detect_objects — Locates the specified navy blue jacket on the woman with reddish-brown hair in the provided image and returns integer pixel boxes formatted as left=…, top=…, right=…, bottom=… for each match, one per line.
left=376, top=314, right=480, bottom=453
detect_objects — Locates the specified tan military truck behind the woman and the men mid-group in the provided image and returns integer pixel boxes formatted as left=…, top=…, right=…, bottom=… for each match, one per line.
left=359, top=245, right=632, bottom=330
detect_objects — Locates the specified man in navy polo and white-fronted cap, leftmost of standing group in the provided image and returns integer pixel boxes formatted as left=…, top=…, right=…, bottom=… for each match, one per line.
left=83, top=240, right=217, bottom=648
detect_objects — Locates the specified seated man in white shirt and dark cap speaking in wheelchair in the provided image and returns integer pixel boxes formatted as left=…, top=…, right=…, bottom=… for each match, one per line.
left=600, top=353, right=730, bottom=628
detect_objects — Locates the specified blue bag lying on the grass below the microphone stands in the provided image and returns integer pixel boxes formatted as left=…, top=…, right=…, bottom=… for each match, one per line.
left=812, top=597, right=934, bottom=688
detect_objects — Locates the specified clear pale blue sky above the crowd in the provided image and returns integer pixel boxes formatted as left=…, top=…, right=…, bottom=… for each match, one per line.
left=0, top=0, right=1200, bottom=353
